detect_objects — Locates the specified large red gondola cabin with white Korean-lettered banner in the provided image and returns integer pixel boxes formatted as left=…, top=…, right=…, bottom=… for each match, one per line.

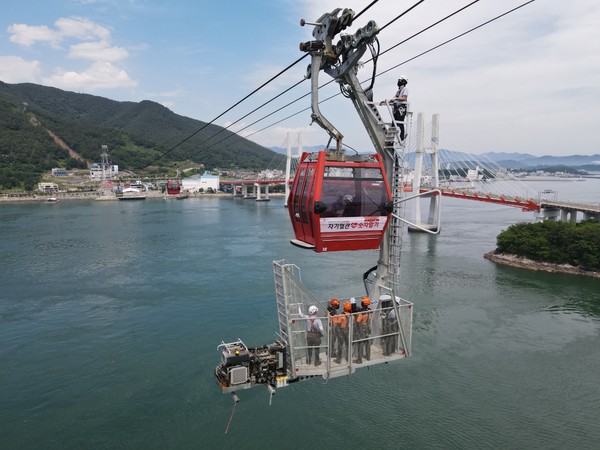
left=288, top=150, right=393, bottom=253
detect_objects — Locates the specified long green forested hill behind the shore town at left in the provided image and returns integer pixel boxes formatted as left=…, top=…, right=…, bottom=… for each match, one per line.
left=0, top=82, right=281, bottom=188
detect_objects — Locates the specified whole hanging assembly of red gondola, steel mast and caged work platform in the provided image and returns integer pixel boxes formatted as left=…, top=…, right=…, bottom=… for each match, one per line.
left=215, top=8, right=436, bottom=401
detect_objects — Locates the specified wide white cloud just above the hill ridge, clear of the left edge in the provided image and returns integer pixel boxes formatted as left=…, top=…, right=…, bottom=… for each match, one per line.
left=42, top=62, right=138, bottom=91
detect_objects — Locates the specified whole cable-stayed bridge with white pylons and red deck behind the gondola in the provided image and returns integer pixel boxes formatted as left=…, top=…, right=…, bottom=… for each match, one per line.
left=227, top=114, right=600, bottom=225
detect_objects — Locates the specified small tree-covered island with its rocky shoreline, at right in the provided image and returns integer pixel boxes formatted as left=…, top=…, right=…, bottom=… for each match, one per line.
left=484, top=220, right=600, bottom=278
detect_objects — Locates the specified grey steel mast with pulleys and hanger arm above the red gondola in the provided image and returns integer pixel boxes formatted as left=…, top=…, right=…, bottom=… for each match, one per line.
left=289, top=8, right=404, bottom=298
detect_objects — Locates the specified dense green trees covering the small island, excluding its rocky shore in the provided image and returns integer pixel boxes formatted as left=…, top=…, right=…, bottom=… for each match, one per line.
left=495, top=220, right=600, bottom=271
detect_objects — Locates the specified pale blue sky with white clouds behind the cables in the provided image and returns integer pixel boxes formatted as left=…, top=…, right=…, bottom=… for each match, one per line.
left=0, top=0, right=600, bottom=156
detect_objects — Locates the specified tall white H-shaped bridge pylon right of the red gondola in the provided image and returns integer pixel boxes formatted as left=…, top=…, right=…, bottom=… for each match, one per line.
left=408, top=113, right=441, bottom=233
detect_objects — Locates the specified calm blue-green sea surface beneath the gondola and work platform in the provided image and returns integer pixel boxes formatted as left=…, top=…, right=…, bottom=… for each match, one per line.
left=0, top=180, right=600, bottom=449
